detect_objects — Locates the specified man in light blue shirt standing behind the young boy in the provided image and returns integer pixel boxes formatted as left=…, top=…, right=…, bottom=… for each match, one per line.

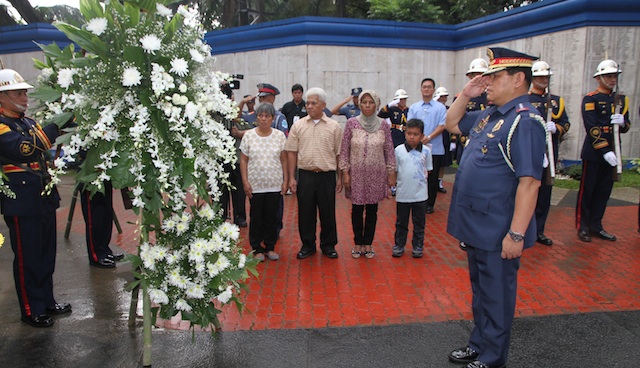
left=407, top=78, right=447, bottom=213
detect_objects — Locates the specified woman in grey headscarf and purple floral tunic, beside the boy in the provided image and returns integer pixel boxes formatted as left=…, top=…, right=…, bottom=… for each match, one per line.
left=339, top=90, right=396, bottom=258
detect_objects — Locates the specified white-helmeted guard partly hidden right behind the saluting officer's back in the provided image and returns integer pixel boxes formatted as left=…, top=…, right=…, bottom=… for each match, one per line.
left=529, top=61, right=571, bottom=245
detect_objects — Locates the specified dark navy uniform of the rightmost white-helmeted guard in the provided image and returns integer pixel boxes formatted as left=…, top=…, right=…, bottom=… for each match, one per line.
left=576, top=90, right=631, bottom=233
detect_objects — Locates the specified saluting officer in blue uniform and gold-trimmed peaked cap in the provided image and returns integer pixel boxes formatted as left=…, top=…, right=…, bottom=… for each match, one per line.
left=447, top=48, right=546, bottom=368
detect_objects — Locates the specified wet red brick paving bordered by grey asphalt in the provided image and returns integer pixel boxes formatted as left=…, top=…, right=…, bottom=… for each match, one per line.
left=58, top=183, right=640, bottom=331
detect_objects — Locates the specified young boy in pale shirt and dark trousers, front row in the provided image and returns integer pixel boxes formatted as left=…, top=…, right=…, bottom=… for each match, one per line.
left=392, top=119, right=433, bottom=258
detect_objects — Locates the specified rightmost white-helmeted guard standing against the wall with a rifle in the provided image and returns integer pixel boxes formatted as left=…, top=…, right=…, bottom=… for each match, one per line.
left=576, top=60, right=630, bottom=242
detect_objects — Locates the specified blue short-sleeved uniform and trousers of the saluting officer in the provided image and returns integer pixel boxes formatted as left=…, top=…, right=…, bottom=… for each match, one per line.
left=447, top=95, right=546, bottom=366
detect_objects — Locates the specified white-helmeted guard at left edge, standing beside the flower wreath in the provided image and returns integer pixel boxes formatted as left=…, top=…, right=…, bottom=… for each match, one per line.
left=0, top=69, right=71, bottom=327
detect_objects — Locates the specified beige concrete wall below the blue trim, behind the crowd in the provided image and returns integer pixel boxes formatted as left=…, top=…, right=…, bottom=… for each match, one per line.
left=2, top=27, right=640, bottom=160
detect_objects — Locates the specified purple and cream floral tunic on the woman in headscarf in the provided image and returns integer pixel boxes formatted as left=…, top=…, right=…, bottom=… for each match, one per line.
left=339, top=118, right=396, bottom=205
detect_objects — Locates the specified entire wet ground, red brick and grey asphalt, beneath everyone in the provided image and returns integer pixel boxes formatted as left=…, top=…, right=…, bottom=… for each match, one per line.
left=0, top=174, right=640, bottom=368
